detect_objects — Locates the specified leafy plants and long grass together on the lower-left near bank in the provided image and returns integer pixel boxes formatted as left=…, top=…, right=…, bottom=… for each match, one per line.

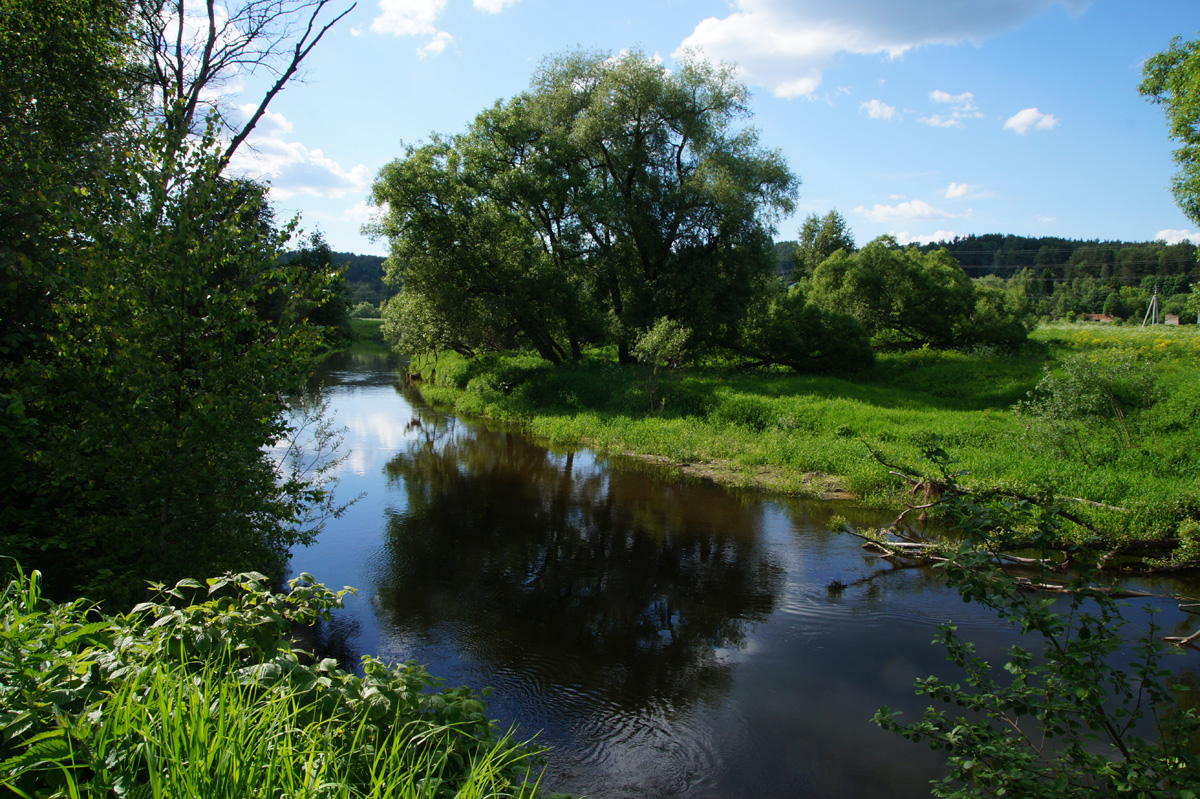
left=0, top=569, right=538, bottom=799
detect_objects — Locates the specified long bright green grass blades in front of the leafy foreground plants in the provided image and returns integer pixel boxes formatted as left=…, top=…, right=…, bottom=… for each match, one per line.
left=6, top=652, right=538, bottom=799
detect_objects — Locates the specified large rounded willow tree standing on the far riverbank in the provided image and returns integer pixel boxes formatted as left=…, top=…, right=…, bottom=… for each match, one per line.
left=373, top=53, right=798, bottom=361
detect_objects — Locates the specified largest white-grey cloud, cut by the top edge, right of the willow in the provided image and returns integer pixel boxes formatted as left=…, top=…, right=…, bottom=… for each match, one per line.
left=680, top=0, right=1090, bottom=97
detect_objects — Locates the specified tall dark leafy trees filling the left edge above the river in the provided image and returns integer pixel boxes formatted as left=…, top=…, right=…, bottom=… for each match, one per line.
left=0, top=0, right=350, bottom=600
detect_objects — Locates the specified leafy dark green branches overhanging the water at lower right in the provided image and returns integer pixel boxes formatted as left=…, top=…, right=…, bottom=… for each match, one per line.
left=875, top=441, right=1200, bottom=799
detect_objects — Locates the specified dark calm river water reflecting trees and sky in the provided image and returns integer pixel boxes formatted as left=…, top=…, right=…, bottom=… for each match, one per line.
left=283, top=348, right=1200, bottom=799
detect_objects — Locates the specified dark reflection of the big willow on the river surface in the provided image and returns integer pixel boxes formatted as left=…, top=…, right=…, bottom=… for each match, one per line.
left=377, top=414, right=785, bottom=708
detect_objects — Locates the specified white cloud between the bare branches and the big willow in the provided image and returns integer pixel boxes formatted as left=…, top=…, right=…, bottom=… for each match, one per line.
left=229, top=106, right=371, bottom=200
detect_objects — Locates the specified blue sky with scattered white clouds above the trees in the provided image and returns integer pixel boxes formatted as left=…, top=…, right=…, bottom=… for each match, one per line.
left=223, top=0, right=1200, bottom=253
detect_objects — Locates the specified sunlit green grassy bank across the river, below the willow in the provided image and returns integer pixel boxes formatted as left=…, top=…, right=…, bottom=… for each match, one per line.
left=414, top=325, right=1200, bottom=539
